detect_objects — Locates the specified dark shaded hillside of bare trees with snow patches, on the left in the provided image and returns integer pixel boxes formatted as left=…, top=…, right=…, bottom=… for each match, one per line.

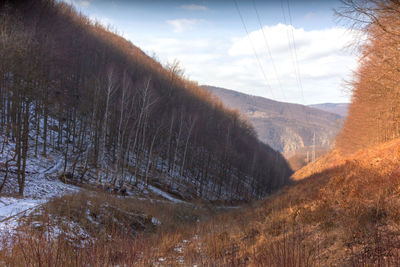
left=0, top=0, right=291, bottom=199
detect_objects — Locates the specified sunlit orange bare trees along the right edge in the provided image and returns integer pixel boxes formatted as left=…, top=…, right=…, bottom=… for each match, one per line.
left=337, top=1, right=400, bottom=152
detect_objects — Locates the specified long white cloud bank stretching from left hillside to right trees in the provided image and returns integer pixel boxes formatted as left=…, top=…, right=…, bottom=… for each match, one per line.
left=131, top=24, right=357, bottom=104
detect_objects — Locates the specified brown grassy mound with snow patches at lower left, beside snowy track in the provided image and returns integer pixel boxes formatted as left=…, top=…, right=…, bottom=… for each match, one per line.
left=0, top=192, right=211, bottom=266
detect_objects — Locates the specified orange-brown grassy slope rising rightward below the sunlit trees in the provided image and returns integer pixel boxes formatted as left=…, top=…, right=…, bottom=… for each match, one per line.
left=141, top=139, right=400, bottom=266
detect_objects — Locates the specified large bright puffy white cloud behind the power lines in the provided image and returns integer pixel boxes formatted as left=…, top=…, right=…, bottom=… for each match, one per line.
left=229, top=24, right=357, bottom=102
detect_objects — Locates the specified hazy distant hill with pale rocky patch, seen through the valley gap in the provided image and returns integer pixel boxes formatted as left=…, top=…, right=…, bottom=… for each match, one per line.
left=203, top=86, right=342, bottom=152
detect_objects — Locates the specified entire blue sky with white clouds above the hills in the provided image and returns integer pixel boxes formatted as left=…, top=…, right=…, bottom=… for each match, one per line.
left=64, top=0, right=358, bottom=104
